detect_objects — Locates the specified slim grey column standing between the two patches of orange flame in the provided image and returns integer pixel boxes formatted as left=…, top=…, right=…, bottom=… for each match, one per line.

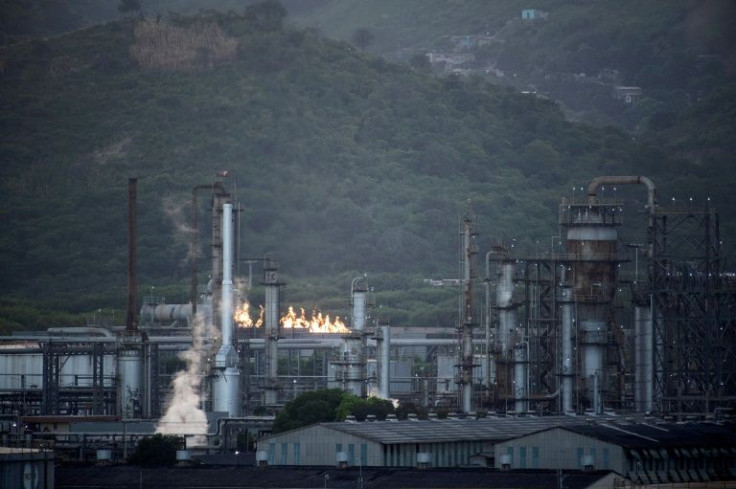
left=263, top=260, right=282, bottom=407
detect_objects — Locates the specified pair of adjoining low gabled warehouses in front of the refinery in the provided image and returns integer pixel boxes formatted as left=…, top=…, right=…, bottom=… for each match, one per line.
left=258, top=416, right=736, bottom=484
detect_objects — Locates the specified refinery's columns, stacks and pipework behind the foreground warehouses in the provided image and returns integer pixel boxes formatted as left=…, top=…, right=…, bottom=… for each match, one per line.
left=0, top=173, right=736, bottom=472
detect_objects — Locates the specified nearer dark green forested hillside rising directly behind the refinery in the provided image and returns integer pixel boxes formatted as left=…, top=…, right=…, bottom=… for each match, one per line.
left=0, top=3, right=731, bottom=324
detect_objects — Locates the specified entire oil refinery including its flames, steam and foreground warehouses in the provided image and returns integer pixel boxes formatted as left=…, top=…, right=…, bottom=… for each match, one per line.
left=0, top=174, right=736, bottom=483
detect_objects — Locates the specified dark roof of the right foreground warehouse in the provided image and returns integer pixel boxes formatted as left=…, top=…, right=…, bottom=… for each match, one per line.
left=562, top=423, right=736, bottom=449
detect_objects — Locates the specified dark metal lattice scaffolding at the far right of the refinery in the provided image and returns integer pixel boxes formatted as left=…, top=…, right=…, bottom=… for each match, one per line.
left=649, top=203, right=736, bottom=416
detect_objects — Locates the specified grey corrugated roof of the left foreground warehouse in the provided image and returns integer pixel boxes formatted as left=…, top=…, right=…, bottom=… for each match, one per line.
left=269, top=416, right=580, bottom=444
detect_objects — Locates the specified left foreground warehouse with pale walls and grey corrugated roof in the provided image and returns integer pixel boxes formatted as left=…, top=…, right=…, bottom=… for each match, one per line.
left=258, top=416, right=580, bottom=467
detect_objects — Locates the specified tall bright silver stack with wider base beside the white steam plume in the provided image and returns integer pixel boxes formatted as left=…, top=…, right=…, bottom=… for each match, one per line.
left=213, top=203, right=241, bottom=418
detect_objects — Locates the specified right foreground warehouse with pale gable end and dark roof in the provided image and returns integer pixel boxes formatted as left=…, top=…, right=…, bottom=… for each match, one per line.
left=495, top=422, right=736, bottom=484
